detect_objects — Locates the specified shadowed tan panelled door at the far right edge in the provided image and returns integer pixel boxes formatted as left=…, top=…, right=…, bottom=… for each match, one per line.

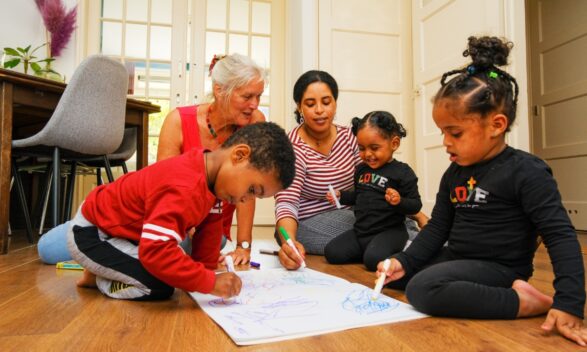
left=528, top=0, right=587, bottom=231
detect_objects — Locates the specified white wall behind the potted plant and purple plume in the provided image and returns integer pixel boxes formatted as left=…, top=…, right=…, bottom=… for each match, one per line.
left=0, top=0, right=80, bottom=79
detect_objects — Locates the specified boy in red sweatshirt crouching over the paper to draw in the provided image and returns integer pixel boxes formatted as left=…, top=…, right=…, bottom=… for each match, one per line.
left=67, top=122, right=295, bottom=300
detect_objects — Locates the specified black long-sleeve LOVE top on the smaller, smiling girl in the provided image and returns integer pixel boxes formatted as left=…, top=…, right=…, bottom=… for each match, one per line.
left=340, top=159, right=422, bottom=236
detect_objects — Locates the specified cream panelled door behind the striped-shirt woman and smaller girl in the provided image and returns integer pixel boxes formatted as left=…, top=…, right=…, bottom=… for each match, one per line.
left=318, top=0, right=415, bottom=167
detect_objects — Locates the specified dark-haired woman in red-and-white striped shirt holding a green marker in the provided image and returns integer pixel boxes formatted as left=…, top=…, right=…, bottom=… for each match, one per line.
left=275, top=70, right=428, bottom=269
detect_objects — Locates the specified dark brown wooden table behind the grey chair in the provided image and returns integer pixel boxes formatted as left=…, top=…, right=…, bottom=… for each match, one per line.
left=0, top=69, right=160, bottom=254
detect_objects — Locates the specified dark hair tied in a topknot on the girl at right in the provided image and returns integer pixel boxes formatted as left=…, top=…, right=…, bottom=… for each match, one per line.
left=434, top=36, right=519, bottom=131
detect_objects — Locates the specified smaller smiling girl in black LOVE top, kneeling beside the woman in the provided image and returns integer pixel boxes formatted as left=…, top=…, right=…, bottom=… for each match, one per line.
left=324, top=111, right=422, bottom=271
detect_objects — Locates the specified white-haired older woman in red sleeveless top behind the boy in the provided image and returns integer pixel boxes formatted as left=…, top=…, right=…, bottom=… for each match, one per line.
left=157, top=54, right=266, bottom=264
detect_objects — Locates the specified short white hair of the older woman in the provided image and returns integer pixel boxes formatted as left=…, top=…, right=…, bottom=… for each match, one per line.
left=210, top=53, right=267, bottom=103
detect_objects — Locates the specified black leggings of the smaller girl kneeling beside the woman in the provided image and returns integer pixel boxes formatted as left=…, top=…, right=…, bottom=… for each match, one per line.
left=324, top=223, right=408, bottom=271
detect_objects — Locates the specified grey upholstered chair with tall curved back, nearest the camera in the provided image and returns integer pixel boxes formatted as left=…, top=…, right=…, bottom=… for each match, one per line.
left=12, top=55, right=128, bottom=226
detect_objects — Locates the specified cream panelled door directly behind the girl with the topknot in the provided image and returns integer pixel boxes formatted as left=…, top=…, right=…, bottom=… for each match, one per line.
left=412, top=0, right=528, bottom=215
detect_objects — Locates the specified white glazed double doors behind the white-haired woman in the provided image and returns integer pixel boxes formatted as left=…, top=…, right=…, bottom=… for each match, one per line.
left=86, top=0, right=285, bottom=163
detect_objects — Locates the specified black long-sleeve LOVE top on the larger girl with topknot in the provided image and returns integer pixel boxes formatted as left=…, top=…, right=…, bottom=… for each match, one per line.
left=397, top=147, right=585, bottom=318
